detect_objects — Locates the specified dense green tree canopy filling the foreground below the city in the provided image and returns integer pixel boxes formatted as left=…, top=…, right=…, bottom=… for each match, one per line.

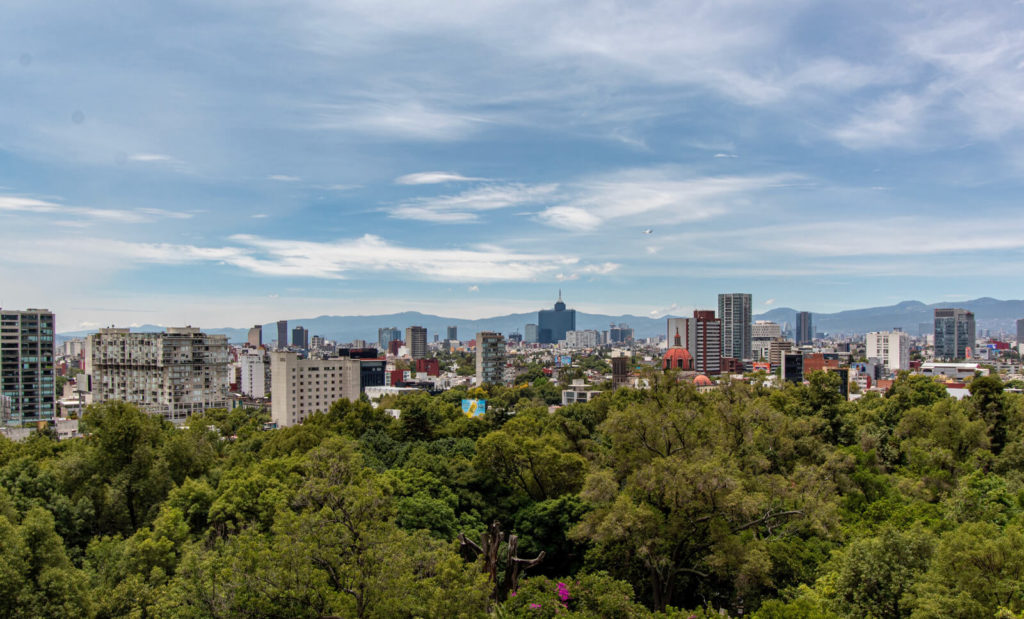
left=0, top=373, right=1024, bottom=619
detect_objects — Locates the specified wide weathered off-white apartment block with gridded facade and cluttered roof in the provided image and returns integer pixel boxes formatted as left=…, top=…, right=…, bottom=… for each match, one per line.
left=85, top=327, right=229, bottom=423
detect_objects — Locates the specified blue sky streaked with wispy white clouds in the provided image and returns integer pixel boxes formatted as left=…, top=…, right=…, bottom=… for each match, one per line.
left=0, top=0, right=1024, bottom=331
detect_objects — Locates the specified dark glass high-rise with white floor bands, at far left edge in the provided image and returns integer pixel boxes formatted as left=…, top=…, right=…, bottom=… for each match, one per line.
left=0, top=308, right=56, bottom=425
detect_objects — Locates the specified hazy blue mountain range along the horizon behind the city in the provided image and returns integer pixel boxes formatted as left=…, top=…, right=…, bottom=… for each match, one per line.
left=54, top=297, right=1024, bottom=342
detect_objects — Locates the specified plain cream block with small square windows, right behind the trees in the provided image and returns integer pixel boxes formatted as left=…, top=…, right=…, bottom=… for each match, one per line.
left=270, top=352, right=362, bottom=427
